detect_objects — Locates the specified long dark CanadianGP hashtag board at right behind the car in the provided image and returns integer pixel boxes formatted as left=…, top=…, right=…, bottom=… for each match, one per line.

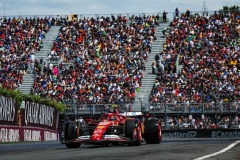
left=163, top=129, right=240, bottom=139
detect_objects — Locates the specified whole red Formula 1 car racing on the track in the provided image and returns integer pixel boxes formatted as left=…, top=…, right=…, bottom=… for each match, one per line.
left=61, top=112, right=162, bottom=148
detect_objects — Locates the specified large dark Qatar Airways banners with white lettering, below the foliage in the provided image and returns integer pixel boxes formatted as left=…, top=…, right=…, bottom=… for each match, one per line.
left=0, top=96, right=59, bottom=130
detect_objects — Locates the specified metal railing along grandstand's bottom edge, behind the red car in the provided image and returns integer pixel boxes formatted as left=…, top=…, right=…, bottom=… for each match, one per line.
left=65, top=102, right=240, bottom=114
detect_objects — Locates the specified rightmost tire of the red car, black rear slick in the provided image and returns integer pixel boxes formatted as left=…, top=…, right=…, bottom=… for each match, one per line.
left=144, top=119, right=162, bottom=144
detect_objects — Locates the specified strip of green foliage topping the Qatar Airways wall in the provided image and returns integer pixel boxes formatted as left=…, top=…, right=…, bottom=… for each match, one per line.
left=0, top=87, right=66, bottom=112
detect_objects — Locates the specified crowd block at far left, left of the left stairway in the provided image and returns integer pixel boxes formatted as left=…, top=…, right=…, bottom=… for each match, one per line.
left=0, top=17, right=50, bottom=90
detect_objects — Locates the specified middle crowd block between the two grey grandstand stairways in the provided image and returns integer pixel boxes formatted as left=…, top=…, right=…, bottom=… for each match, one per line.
left=31, top=15, right=159, bottom=104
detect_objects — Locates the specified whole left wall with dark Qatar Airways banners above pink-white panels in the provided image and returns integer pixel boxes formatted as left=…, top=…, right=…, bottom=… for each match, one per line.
left=0, top=96, right=59, bottom=142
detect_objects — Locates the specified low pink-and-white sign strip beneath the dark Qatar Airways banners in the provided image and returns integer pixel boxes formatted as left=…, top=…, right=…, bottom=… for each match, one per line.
left=0, top=126, right=59, bottom=143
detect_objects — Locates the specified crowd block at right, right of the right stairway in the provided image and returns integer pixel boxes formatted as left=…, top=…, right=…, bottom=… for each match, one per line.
left=150, top=11, right=240, bottom=107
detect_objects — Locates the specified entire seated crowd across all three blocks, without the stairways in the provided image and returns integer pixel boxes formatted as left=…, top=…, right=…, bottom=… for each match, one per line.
left=0, top=11, right=240, bottom=117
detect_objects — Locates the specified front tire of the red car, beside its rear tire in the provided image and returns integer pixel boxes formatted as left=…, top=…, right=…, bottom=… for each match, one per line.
left=125, top=119, right=142, bottom=146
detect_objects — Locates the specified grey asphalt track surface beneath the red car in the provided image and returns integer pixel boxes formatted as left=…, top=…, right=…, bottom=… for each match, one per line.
left=0, top=139, right=240, bottom=160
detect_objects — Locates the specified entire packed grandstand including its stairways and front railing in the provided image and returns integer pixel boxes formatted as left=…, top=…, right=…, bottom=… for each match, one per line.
left=0, top=9, right=240, bottom=130
